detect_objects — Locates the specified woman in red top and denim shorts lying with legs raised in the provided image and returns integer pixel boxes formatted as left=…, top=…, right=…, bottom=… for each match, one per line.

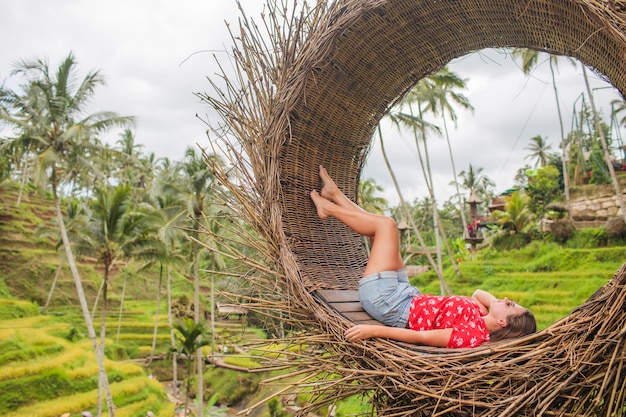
left=310, top=166, right=537, bottom=348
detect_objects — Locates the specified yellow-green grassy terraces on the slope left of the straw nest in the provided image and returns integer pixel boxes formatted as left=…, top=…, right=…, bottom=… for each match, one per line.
left=0, top=189, right=272, bottom=417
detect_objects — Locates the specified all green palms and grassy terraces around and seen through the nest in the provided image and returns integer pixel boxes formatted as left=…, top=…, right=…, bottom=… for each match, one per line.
left=0, top=51, right=626, bottom=416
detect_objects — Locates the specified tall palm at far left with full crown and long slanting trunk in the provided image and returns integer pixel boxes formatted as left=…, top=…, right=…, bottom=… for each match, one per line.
left=0, top=53, right=132, bottom=417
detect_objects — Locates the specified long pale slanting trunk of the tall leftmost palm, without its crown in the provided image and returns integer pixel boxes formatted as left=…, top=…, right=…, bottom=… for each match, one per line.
left=53, top=193, right=115, bottom=417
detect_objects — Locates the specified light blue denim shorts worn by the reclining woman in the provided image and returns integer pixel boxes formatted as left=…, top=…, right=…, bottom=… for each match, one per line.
left=359, top=269, right=420, bottom=328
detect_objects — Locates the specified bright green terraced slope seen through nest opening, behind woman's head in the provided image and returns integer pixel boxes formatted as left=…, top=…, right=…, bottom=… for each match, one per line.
left=414, top=243, right=626, bottom=329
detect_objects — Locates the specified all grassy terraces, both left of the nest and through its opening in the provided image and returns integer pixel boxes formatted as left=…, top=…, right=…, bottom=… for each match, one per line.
left=0, top=184, right=626, bottom=417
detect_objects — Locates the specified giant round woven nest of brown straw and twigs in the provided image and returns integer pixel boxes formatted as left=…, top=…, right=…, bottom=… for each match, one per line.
left=199, top=0, right=626, bottom=416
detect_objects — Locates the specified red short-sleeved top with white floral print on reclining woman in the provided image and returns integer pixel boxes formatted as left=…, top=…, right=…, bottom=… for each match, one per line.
left=408, top=295, right=489, bottom=348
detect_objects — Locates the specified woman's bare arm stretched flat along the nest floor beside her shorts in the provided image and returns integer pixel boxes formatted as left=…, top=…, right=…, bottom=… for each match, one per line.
left=345, top=324, right=452, bottom=347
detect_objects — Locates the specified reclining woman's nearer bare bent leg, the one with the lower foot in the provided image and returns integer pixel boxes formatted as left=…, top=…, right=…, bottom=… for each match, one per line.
left=310, top=190, right=404, bottom=276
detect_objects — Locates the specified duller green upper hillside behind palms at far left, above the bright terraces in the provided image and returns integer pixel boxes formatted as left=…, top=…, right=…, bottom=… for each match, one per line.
left=0, top=187, right=191, bottom=310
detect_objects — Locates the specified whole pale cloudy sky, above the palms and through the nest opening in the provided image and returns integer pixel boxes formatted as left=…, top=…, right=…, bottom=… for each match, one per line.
left=0, top=0, right=624, bottom=203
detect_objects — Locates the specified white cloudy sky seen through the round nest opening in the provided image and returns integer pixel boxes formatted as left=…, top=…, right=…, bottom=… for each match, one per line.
left=364, top=50, right=619, bottom=203
